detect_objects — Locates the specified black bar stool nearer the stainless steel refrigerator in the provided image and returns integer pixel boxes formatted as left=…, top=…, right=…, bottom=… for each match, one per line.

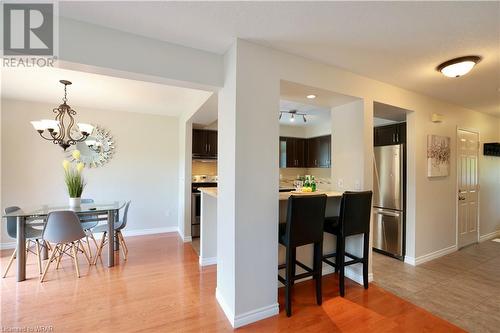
left=323, top=191, right=372, bottom=297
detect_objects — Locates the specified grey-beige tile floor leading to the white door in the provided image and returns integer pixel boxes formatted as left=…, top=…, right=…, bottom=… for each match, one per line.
left=373, top=241, right=500, bottom=332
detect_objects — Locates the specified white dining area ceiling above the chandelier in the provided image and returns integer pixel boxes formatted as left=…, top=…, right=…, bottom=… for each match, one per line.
left=1, top=67, right=212, bottom=116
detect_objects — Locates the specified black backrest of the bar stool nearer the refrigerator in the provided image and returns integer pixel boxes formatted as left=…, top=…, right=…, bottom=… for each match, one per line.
left=340, top=191, right=373, bottom=236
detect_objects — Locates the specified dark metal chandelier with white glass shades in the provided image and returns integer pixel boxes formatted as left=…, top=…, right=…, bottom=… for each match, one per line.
left=31, top=80, right=94, bottom=150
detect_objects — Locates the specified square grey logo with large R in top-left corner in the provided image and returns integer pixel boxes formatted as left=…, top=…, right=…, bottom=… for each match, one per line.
left=3, top=3, right=54, bottom=56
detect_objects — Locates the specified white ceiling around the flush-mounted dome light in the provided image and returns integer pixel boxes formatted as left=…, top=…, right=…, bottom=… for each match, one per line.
left=59, top=1, right=500, bottom=115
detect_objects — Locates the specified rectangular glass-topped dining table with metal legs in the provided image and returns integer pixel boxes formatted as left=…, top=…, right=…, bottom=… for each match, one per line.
left=2, top=201, right=125, bottom=282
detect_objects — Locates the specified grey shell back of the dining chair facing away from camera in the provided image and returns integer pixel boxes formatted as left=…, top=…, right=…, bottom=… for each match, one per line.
left=43, top=210, right=85, bottom=243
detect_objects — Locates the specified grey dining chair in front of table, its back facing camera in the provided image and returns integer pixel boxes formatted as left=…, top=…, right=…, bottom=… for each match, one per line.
left=40, top=210, right=90, bottom=282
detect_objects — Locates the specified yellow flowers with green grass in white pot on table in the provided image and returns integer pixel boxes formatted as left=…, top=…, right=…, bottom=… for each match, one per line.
left=63, top=150, right=86, bottom=208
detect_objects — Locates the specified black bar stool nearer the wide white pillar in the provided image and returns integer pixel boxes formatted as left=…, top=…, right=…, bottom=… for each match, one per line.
left=278, top=194, right=327, bottom=317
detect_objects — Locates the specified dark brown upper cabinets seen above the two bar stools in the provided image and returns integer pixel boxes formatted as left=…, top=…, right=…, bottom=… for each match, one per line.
left=279, top=135, right=331, bottom=168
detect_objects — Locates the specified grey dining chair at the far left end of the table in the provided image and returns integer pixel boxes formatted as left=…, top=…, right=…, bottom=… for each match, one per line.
left=3, top=206, right=50, bottom=278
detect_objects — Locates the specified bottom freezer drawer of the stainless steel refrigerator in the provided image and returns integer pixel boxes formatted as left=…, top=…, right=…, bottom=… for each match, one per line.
left=373, top=208, right=404, bottom=257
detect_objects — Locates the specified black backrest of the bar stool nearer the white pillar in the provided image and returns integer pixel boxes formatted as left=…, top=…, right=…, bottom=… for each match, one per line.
left=286, top=194, right=327, bottom=246
